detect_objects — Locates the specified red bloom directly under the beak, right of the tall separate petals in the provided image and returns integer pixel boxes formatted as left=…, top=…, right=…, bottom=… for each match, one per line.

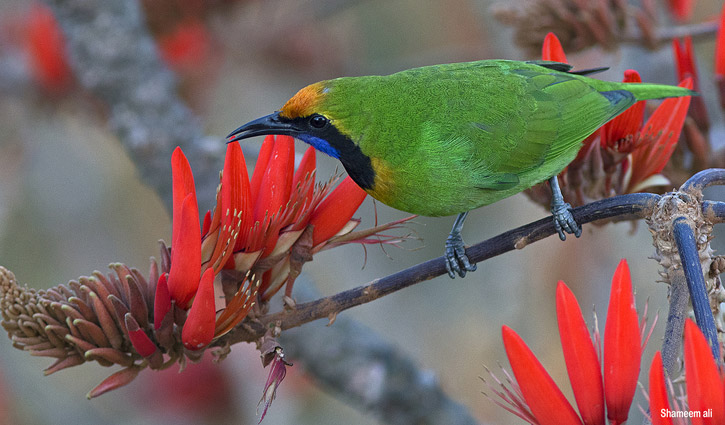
left=195, top=136, right=410, bottom=337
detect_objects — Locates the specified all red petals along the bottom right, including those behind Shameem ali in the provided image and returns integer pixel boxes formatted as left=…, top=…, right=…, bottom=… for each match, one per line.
left=489, top=260, right=725, bottom=425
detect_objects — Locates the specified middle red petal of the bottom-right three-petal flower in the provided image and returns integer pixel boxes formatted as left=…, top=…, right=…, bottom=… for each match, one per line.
left=556, top=281, right=605, bottom=425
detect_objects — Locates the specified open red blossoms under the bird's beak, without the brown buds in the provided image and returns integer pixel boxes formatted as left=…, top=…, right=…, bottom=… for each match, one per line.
left=164, top=136, right=410, bottom=350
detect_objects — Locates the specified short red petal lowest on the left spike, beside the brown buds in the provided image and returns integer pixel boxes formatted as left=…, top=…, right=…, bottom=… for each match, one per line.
left=181, top=268, right=216, bottom=350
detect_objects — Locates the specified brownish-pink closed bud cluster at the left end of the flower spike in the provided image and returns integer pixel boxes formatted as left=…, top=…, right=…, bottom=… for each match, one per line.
left=0, top=250, right=194, bottom=397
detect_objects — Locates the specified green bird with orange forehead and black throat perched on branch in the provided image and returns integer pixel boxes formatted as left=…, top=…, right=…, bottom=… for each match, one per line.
left=228, top=60, right=695, bottom=278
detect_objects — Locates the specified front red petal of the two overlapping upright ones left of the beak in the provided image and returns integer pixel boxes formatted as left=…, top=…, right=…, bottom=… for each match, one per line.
left=166, top=194, right=201, bottom=309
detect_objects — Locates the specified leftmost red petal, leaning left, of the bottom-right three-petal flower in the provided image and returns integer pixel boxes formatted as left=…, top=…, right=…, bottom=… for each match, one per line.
left=501, top=326, right=581, bottom=425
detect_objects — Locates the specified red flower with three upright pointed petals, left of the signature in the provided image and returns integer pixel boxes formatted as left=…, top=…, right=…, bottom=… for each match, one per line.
left=486, top=260, right=641, bottom=425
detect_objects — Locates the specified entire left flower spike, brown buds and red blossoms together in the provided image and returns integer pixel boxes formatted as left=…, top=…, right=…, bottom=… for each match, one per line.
left=0, top=136, right=408, bottom=398
